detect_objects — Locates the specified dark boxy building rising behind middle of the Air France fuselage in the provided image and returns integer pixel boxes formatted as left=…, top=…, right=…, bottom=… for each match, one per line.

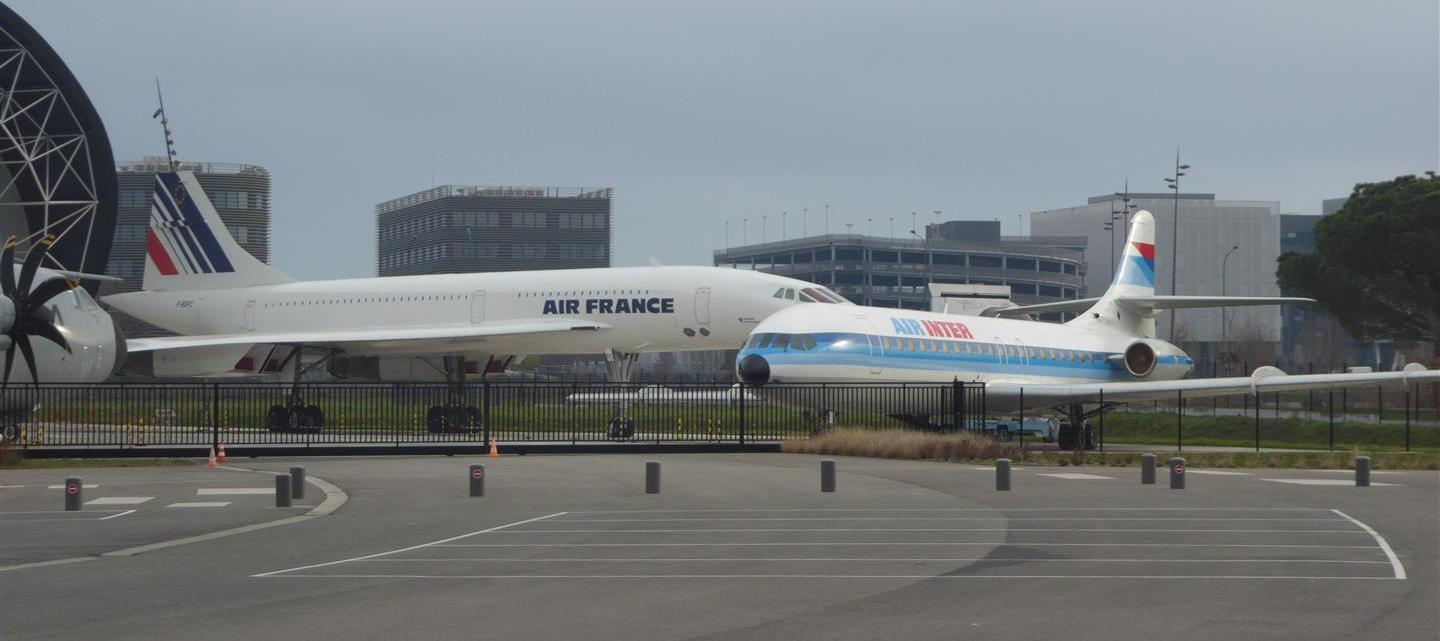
left=374, top=184, right=613, bottom=277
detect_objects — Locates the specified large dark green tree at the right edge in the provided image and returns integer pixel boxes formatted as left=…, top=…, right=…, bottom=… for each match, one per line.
left=1277, top=171, right=1440, bottom=356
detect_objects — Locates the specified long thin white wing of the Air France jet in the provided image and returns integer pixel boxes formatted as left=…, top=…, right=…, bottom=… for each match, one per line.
left=125, top=320, right=609, bottom=353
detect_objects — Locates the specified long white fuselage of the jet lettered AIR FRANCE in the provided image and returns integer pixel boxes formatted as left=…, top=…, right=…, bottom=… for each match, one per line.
left=105, top=266, right=812, bottom=356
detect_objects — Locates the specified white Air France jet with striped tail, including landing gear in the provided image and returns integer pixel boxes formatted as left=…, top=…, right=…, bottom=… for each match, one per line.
left=102, top=171, right=847, bottom=431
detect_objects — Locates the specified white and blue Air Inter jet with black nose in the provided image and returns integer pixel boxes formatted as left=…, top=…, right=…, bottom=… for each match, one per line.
left=736, top=212, right=1440, bottom=448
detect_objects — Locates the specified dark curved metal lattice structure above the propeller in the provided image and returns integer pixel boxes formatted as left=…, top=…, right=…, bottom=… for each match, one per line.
left=0, top=4, right=117, bottom=292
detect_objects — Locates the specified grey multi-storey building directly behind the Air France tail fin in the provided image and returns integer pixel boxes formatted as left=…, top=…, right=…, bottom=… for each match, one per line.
left=101, top=156, right=271, bottom=337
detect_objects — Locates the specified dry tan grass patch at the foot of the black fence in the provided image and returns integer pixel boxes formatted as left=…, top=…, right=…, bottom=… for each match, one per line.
left=780, top=428, right=1021, bottom=461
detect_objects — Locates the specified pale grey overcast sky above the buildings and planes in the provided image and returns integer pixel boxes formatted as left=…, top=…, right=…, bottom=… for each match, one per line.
left=12, top=0, right=1440, bottom=278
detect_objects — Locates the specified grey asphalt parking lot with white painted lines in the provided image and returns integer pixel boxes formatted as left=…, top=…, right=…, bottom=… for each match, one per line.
left=0, top=454, right=1440, bottom=641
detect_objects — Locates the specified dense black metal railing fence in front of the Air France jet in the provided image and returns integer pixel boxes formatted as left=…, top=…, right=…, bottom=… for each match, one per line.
left=3, top=382, right=985, bottom=454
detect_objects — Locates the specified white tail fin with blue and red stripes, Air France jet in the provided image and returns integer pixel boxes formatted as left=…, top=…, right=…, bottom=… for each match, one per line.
left=141, top=171, right=291, bottom=290
